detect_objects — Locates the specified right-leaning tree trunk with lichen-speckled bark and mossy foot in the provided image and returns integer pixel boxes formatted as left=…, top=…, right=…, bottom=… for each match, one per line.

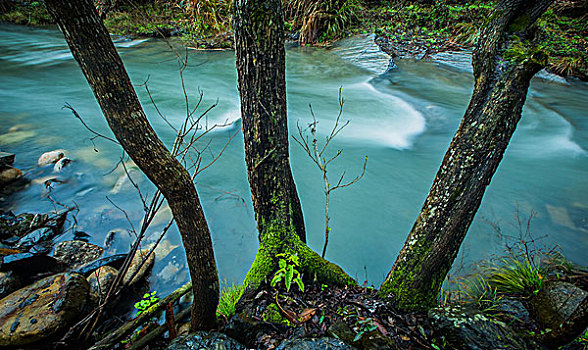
left=380, top=0, right=552, bottom=309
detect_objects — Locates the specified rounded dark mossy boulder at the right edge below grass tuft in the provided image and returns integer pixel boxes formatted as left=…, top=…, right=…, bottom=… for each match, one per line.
left=530, top=282, right=588, bottom=329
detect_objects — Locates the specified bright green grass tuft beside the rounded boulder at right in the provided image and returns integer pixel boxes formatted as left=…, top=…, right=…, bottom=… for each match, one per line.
left=488, top=256, right=543, bottom=297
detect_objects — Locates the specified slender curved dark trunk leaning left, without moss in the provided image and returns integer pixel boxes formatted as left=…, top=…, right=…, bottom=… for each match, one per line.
left=45, top=0, right=219, bottom=330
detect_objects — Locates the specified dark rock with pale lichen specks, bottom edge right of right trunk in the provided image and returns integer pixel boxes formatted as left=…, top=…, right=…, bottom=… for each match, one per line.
left=429, top=304, right=532, bottom=350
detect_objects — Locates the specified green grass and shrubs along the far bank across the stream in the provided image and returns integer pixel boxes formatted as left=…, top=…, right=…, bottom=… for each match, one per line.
left=0, top=0, right=588, bottom=80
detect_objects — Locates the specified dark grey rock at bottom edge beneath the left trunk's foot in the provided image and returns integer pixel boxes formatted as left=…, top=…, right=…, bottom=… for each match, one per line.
left=166, top=332, right=247, bottom=350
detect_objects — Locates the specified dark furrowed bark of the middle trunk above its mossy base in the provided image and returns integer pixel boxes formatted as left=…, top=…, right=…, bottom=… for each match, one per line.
left=233, top=0, right=306, bottom=242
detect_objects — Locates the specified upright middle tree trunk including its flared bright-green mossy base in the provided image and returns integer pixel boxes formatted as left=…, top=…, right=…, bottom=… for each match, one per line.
left=233, top=0, right=354, bottom=290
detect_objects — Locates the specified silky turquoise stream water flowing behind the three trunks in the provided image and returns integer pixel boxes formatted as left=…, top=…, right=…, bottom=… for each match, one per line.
left=0, top=24, right=588, bottom=294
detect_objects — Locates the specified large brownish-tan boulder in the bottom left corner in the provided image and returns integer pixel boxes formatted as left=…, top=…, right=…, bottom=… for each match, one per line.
left=0, top=273, right=88, bottom=346
